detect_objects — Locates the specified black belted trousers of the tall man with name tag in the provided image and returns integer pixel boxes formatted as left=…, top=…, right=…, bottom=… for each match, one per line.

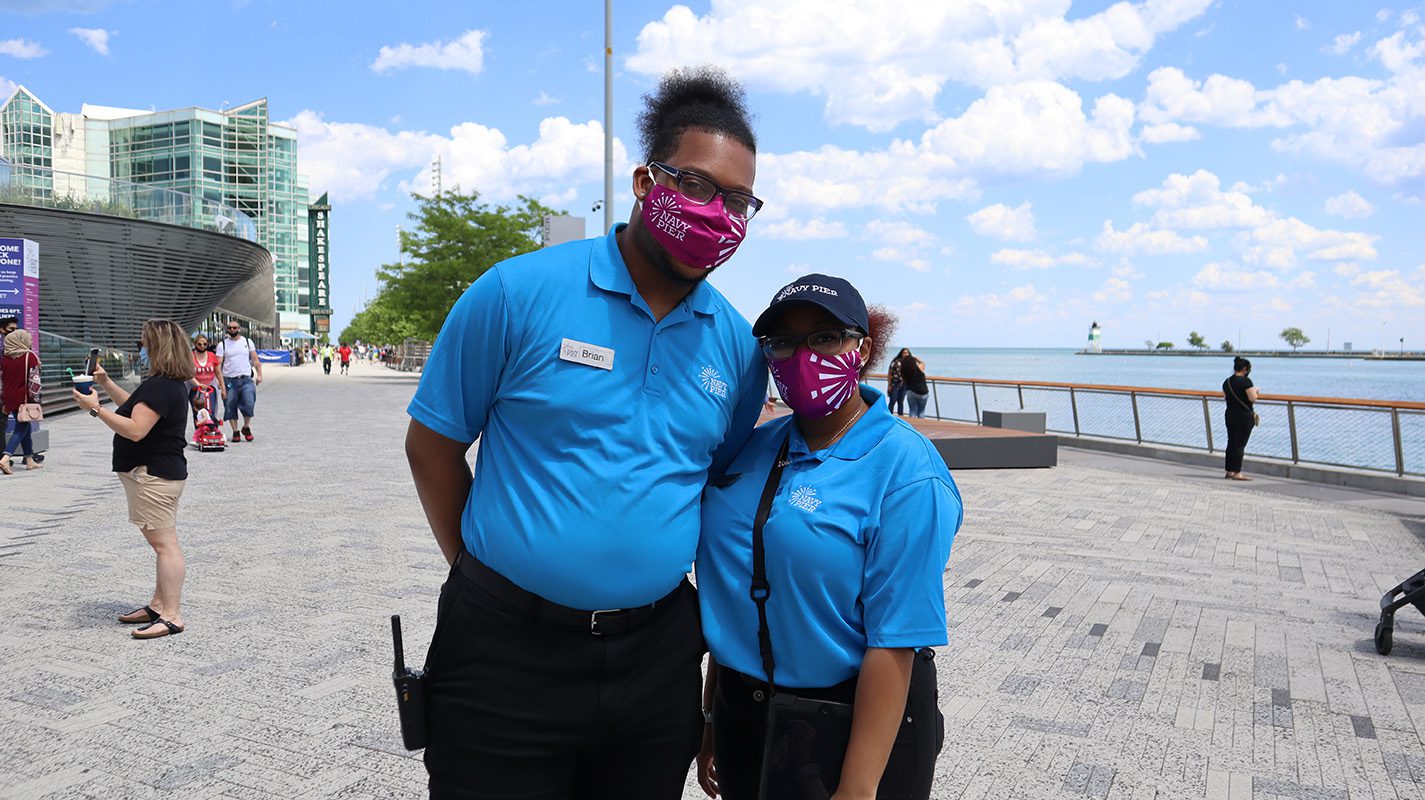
left=425, top=559, right=705, bottom=800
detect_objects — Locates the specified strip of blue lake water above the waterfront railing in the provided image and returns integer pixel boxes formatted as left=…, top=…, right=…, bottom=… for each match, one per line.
left=875, top=348, right=1425, bottom=402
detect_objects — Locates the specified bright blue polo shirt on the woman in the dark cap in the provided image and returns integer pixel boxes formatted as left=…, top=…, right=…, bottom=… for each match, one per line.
left=697, top=385, right=962, bottom=689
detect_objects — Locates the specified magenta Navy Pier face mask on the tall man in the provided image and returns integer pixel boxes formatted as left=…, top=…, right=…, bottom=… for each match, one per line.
left=643, top=184, right=747, bottom=270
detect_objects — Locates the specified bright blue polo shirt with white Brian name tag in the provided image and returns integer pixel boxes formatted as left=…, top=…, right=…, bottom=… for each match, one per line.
left=408, top=225, right=767, bottom=610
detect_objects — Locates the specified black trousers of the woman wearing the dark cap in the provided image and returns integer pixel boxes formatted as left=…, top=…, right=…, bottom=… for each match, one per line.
left=713, top=652, right=945, bottom=800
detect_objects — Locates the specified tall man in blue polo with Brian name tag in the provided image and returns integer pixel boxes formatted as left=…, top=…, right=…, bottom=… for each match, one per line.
left=406, top=70, right=765, bottom=800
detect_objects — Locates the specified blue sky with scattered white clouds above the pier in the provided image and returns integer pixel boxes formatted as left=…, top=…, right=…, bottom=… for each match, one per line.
left=0, top=0, right=1425, bottom=349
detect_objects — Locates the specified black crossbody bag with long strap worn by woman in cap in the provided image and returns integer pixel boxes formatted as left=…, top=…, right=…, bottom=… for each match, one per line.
left=751, top=434, right=852, bottom=800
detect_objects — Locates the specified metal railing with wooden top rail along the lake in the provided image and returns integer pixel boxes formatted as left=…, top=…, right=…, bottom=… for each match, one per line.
left=871, top=375, right=1425, bottom=476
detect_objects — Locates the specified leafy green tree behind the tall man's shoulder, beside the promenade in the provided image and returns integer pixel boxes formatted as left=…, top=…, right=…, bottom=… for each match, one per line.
left=342, top=191, right=554, bottom=342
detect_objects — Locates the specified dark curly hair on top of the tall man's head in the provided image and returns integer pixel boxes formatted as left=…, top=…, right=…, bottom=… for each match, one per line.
left=638, top=67, right=757, bottom=161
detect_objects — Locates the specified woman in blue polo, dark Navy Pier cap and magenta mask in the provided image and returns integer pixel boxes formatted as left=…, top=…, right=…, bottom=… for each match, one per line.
left=697, top=275, right=962, bottom=800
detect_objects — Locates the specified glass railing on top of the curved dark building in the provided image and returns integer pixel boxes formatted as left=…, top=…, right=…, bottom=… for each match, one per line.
left=0, top=164, right=258, bottom=242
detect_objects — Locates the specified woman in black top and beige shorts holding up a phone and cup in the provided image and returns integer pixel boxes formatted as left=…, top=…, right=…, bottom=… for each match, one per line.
left=73, top=319, right=194, bottom=639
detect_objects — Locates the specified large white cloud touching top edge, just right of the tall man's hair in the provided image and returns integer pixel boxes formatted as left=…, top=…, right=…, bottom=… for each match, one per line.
left=626, top=0, right=1211, bottom=131
